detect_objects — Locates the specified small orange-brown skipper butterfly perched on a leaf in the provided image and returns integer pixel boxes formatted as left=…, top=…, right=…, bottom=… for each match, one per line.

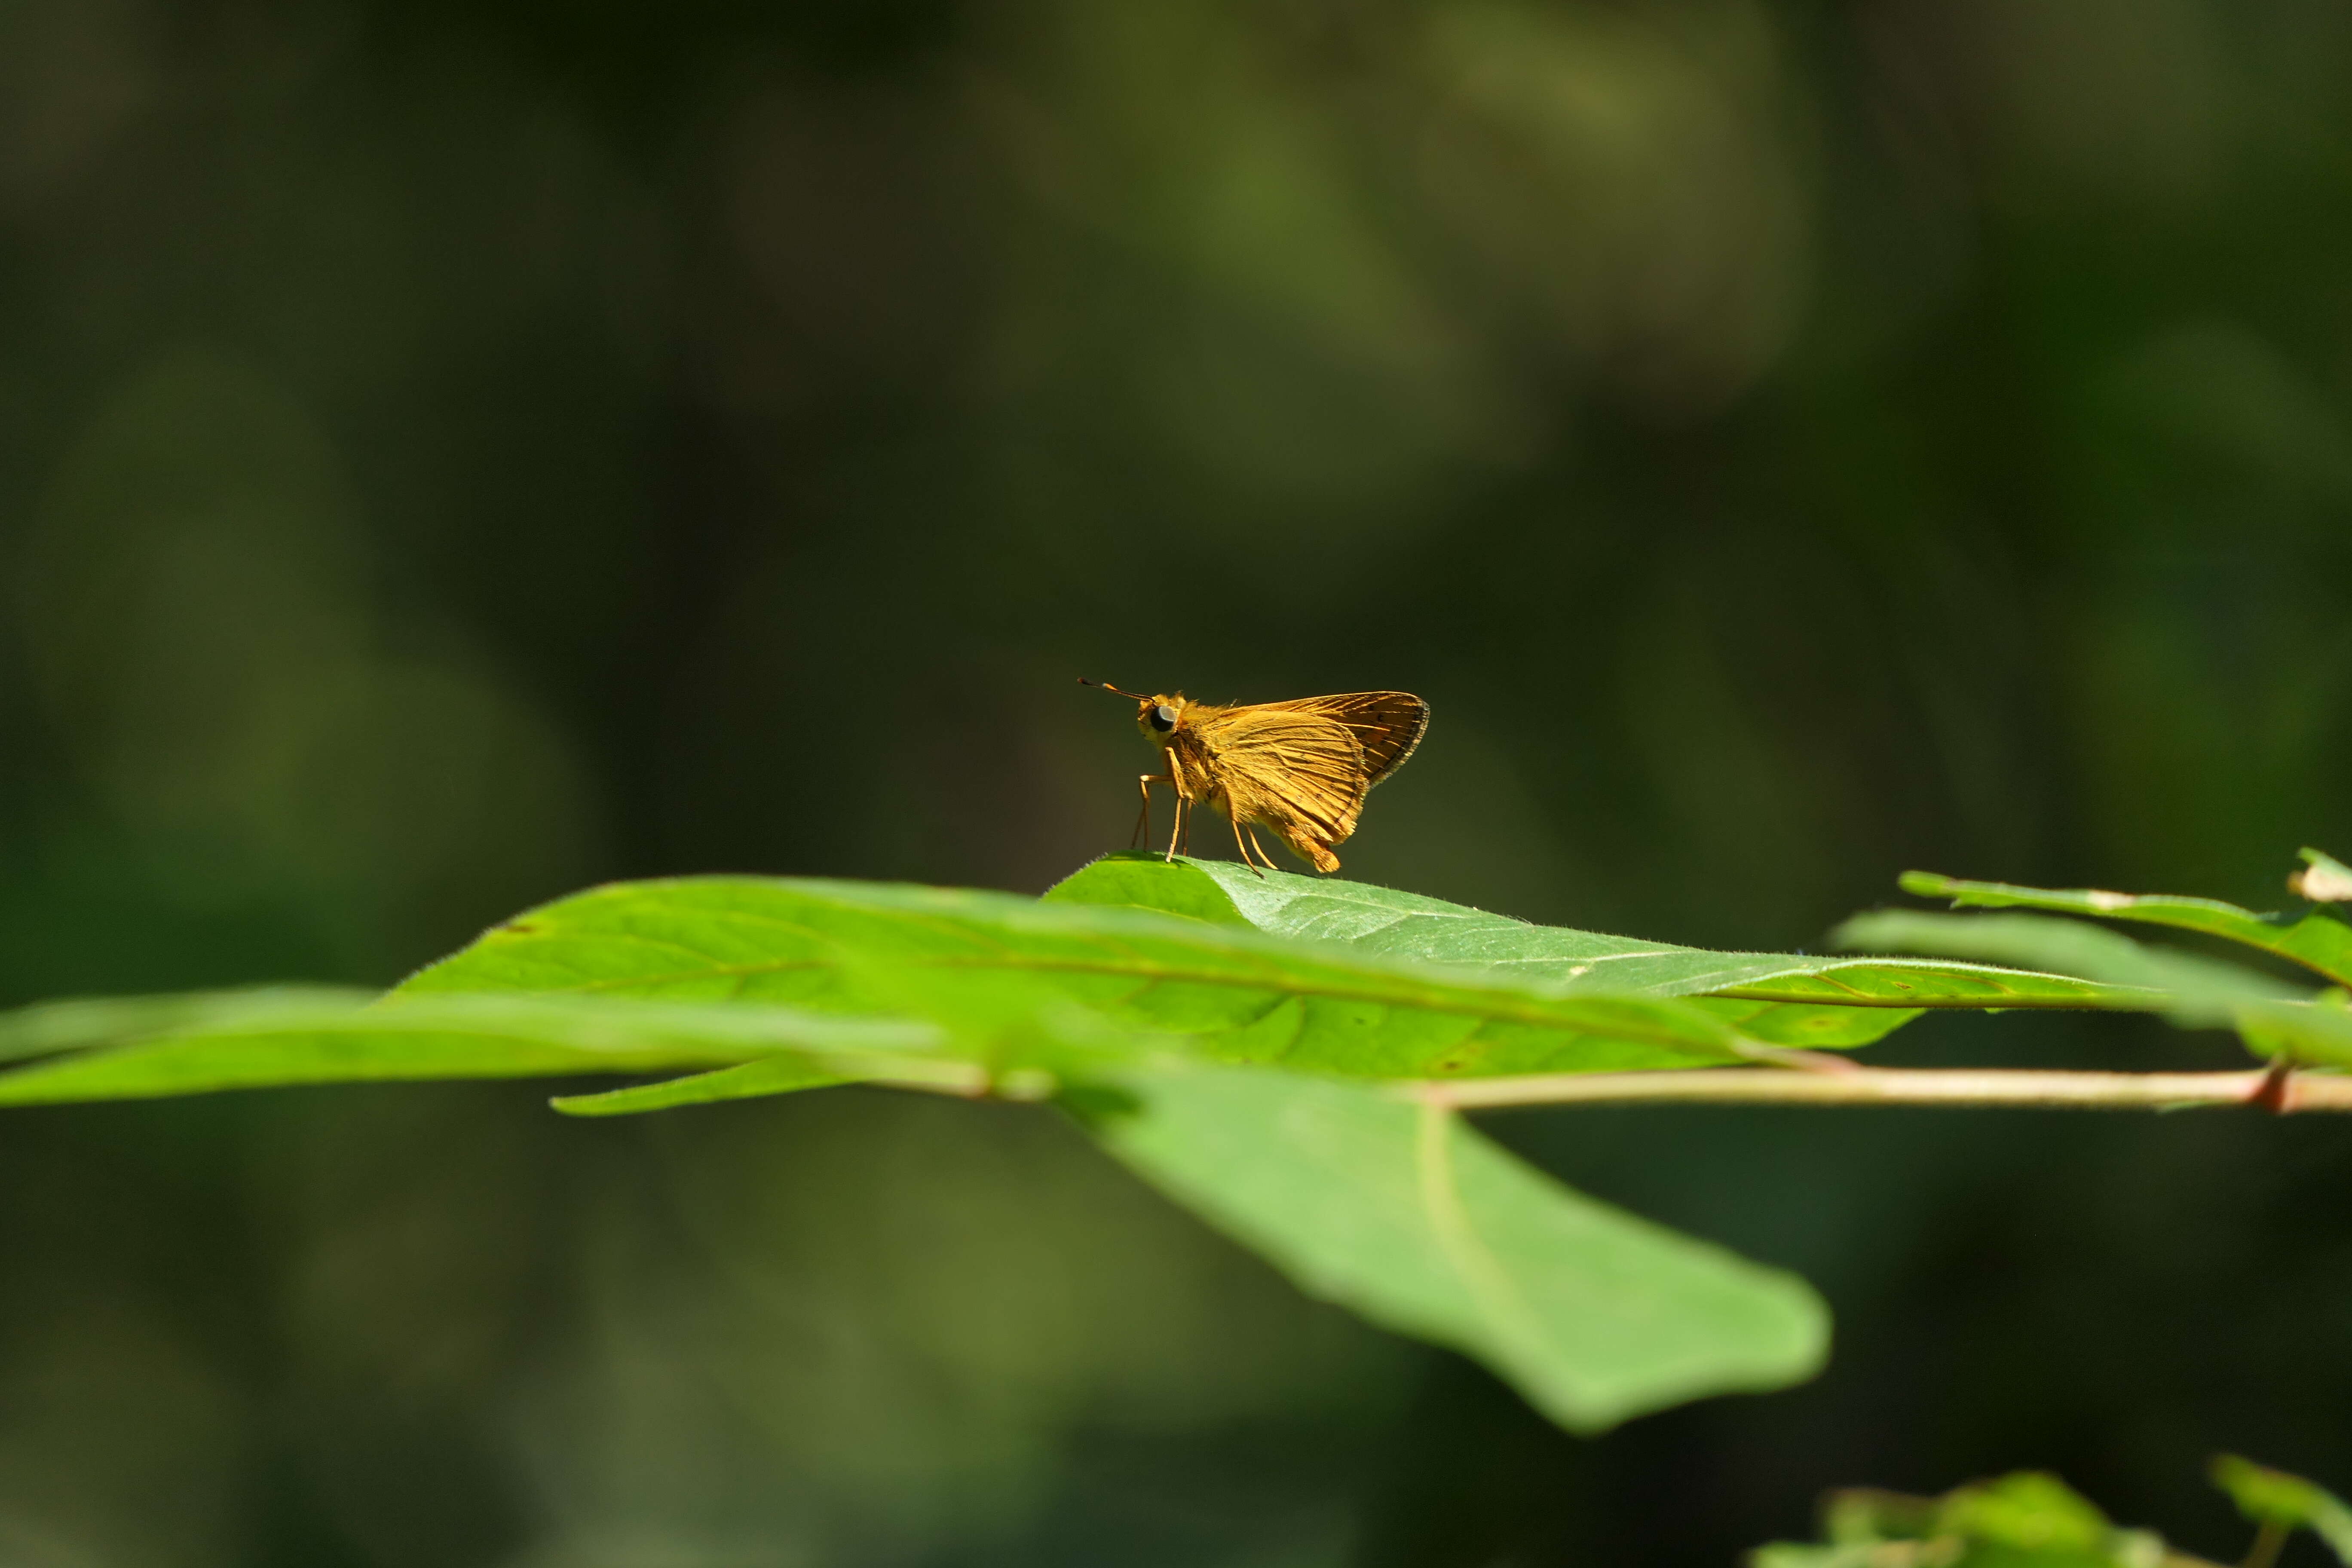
left=1077, top=677, right=1430, bottom=875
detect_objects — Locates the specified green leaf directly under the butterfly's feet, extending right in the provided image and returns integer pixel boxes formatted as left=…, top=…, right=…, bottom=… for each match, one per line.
left=1047, top=856, right=2154, bottom=1044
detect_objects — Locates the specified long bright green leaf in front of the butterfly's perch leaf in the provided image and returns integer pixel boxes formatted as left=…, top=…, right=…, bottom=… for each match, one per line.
left=395, top=877, right=1778, bottom=1077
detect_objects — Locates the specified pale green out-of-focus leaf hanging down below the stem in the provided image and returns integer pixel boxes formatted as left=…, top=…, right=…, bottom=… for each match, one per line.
left=1080, top=1065, right=1828, bottom=1432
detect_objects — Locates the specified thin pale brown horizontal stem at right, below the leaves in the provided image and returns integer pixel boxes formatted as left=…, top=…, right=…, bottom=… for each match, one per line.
left=1400, top=1065, right=2352, bottom=1114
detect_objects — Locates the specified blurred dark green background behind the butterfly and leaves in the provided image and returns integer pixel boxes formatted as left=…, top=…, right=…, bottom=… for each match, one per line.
left=0, top=0, right=2352, bottom=1568
